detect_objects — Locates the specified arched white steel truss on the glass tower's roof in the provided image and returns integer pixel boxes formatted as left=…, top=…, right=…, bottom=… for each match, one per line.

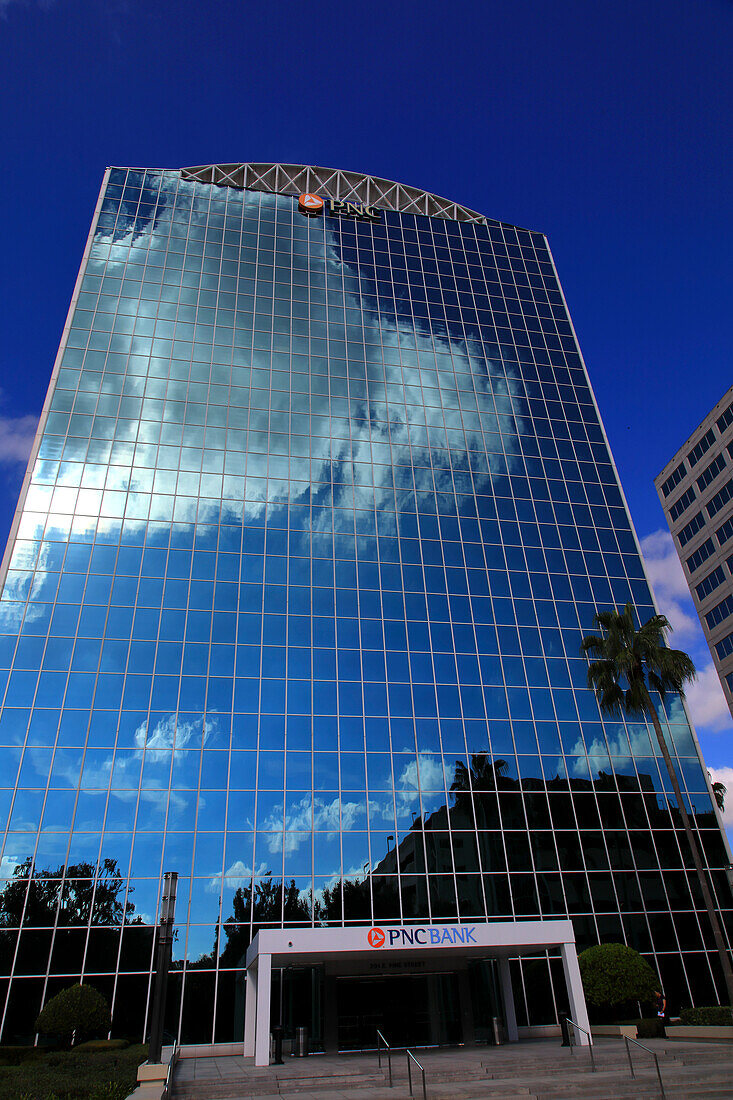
left=180, top=164, right=486, bottom=226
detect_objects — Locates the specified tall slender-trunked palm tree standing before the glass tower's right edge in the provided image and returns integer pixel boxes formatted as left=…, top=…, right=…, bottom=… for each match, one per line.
left=580, top=604, right=733, bottom=1004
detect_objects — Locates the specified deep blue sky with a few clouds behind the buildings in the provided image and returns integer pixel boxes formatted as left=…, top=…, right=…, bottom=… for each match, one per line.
left=0, top=0, right=733, bottom=777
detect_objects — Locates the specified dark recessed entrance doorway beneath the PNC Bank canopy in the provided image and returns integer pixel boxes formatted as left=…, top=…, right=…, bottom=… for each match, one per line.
left=336, top=971, right=462, bottom=1051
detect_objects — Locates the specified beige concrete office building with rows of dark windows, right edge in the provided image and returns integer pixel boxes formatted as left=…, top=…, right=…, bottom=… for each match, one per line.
left=654, top=386, right=733, bottom=714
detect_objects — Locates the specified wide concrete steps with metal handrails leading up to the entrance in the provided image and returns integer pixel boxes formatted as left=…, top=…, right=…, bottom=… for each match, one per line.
left=168, top=1040, right=733, bottom=1100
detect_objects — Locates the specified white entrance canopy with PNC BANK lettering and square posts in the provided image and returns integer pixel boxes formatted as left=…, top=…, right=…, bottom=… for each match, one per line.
left=244, top=921, right=590, bottom=1066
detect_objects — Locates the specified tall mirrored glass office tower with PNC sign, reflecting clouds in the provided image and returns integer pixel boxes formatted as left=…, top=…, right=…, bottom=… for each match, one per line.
left=0, top=165, right=731, bottom=1042
